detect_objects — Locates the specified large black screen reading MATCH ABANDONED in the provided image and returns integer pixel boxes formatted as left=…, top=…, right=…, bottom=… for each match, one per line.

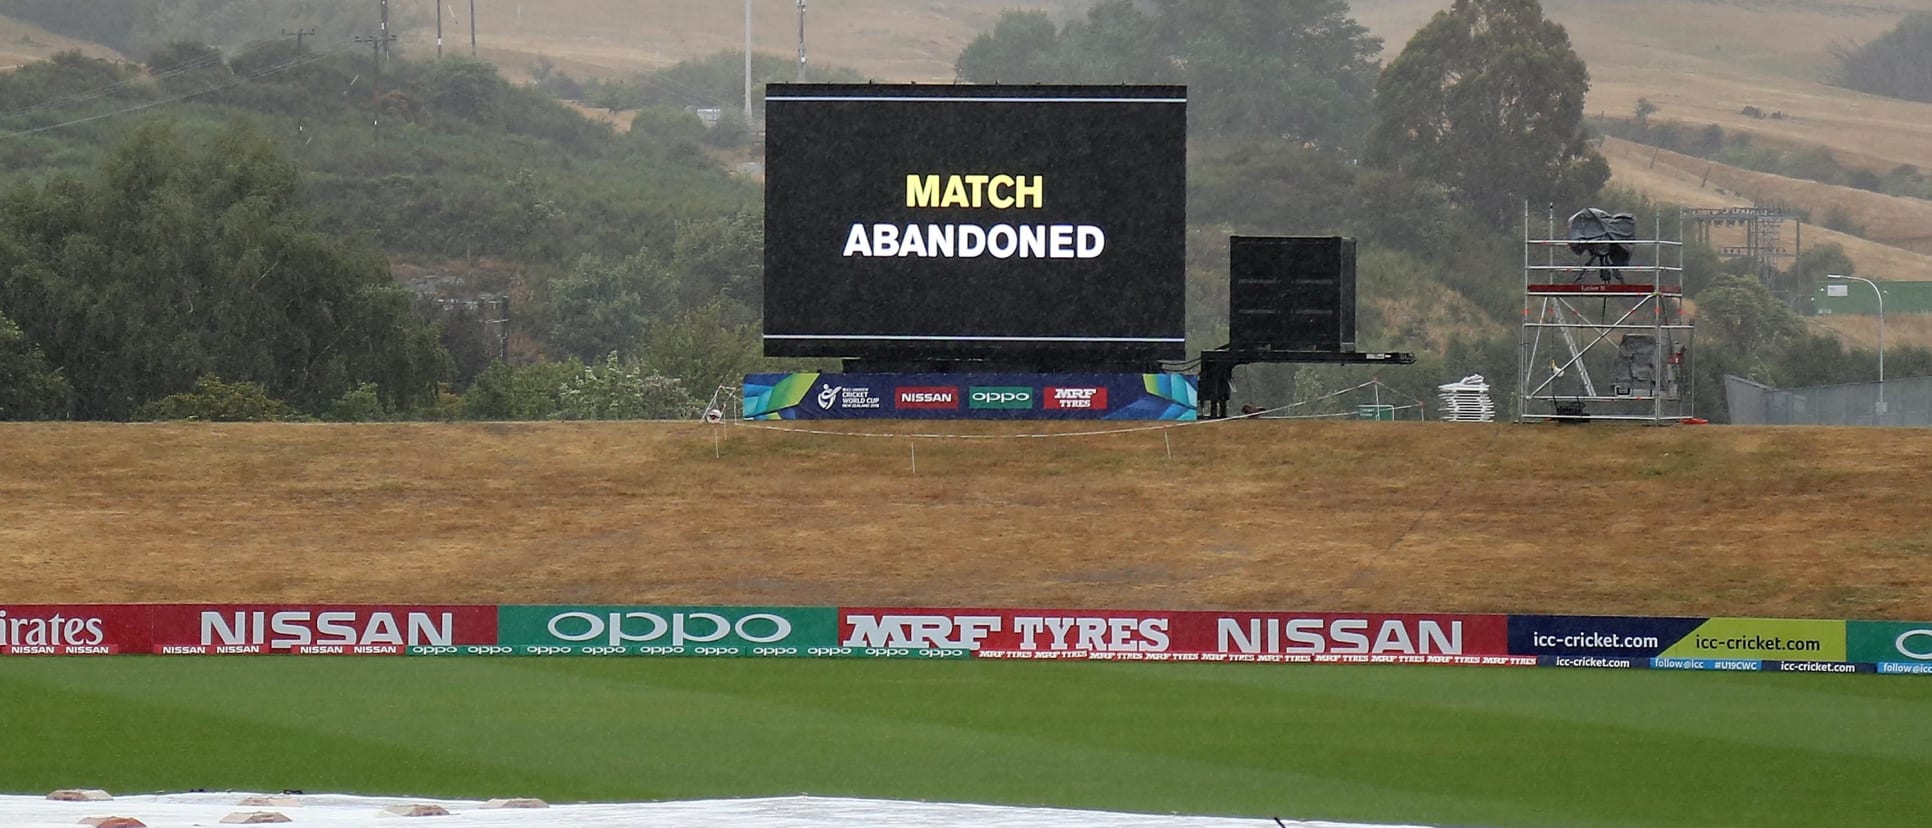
left=765, top=83, right=1186, bottom=359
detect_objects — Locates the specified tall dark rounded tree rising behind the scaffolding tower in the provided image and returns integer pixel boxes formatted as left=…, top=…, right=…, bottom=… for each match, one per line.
left=1366, top=0, right=1609, bottom=230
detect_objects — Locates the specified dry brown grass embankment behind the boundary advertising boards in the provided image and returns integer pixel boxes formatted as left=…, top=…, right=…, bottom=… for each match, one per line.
left=0, top=421, right=1932, bottom=620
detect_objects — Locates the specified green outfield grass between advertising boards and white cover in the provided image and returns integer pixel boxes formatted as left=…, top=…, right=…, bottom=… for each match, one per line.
left=0, top=656, right=1932, bottom=828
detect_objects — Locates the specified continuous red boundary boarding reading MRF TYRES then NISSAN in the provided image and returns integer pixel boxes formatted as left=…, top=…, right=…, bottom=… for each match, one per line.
left=838, top=608, right=1536, bottom=664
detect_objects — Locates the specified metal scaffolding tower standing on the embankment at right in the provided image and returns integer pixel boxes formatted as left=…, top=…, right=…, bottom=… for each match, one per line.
left=1517, top=210, right=1694, bottom=425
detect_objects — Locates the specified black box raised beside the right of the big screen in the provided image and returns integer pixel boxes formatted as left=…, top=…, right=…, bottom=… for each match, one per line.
left=1227, top=235, right=1354, bottom=351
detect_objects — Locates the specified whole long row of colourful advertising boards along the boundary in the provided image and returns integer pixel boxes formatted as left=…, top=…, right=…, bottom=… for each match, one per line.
left=0, top=604, right=1932, bottom=676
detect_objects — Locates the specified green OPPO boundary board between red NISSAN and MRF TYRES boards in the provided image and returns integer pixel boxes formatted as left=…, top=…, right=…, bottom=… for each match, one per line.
left=495, top=606, right=838, bottom=656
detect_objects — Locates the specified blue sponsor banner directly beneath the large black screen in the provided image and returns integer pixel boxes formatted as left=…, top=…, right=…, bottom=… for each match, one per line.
left=744, top=374, right=1198, bottom=421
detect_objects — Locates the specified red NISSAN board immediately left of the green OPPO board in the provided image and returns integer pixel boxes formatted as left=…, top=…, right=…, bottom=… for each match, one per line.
left=153, top=604, right=497, bottom=656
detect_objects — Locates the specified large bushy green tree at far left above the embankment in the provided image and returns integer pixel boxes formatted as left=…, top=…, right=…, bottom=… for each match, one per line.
left=0, top=122, right=448, bottom=419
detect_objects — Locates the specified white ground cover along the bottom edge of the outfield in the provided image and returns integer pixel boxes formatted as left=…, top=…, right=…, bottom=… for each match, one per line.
left=0, top=793, right=1437, bottom=828
